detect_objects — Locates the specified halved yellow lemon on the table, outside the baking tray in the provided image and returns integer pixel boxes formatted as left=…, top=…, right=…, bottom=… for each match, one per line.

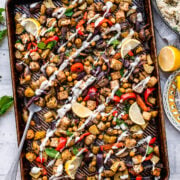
left=158, top=46, right=180, bottom=72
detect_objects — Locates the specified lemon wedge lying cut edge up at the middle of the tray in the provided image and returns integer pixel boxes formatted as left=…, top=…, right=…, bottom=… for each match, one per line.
left=72, top=102, right=92, bottom=118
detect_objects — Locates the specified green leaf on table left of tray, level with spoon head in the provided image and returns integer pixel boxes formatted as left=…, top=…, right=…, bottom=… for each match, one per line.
left=0, top=96, right=13, bottom=115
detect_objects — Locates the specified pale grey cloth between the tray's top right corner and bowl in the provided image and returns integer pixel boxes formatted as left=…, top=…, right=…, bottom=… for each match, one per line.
left=152, top=0, right=180, bottom=48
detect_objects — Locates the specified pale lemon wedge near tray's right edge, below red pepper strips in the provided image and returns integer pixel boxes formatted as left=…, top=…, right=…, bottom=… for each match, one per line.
left=129, top=102, right=145, bottom=125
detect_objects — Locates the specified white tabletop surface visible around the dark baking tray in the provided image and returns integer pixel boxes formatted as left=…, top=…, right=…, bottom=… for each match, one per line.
left=0, top=0, right=180, bottom=180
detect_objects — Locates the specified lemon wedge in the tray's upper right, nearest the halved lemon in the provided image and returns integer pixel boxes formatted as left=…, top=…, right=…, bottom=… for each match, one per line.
left=121, top=39, right=141, bottom=58
